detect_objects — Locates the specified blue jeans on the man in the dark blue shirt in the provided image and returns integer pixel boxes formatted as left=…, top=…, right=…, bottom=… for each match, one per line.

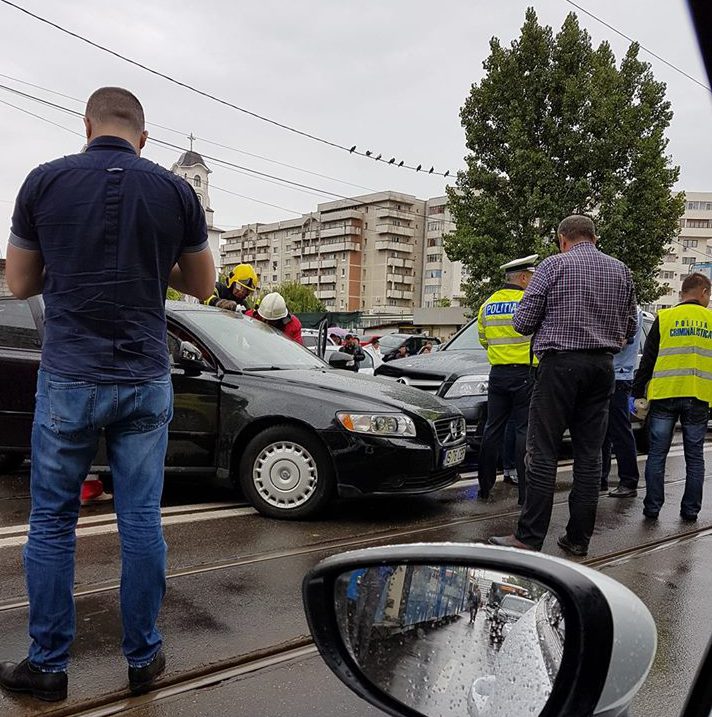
left=24, top=369, right=173, bottom=672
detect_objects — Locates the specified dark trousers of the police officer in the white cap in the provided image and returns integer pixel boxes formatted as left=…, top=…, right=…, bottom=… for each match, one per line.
left=477, top=364, right=533, bottom=503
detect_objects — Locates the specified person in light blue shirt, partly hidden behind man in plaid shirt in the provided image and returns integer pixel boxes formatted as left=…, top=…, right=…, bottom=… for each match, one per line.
left=601, top=310, right=643, bottom=498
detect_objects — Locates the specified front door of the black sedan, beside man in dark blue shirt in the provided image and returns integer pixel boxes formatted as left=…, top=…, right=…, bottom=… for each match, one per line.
left=166, top=321, right=220, bottom=473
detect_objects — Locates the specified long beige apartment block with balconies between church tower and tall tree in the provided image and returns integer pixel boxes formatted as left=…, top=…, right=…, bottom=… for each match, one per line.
left=220, top=191, right=427, bottom=314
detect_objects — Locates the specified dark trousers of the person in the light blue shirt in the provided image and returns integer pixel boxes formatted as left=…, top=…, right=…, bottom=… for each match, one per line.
left=601, top=381, right=640, bottom=488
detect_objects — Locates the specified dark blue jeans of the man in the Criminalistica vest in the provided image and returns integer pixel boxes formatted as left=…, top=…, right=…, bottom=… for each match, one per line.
left=643, top=398, right=709, bottom=516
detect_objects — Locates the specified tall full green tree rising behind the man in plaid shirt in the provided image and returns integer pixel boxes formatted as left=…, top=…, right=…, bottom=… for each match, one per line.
left=445, top=8, right=685, bottom=308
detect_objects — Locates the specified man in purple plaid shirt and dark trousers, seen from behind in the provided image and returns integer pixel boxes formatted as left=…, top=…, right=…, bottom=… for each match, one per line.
left=490, top=215, right=637, bottom=555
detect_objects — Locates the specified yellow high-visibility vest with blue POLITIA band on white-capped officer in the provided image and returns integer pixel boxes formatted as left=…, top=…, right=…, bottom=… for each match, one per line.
left=477, top=289, right=536, bottom=366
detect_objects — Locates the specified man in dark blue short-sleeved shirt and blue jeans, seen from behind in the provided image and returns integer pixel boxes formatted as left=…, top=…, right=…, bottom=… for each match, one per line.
left=0, top=87, right=215, bottom=700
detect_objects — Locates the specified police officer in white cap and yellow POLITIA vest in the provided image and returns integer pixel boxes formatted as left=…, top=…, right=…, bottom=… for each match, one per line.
left=477, top=254, right=538, bottom=505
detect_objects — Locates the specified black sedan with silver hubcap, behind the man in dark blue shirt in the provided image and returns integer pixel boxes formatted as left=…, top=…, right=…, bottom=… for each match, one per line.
left=0, top=299, right=465, bottom=518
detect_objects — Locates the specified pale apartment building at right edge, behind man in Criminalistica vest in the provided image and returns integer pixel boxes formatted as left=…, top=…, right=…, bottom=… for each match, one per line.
left=644, top=192, right=712, bottom=311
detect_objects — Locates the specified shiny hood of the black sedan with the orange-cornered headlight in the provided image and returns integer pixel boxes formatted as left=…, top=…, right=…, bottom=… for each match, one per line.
left=225, top=369, right=458, bottom=420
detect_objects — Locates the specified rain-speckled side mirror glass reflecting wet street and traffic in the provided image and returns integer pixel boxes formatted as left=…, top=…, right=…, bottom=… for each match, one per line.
left=334, top=564, right=565, bottom=717
